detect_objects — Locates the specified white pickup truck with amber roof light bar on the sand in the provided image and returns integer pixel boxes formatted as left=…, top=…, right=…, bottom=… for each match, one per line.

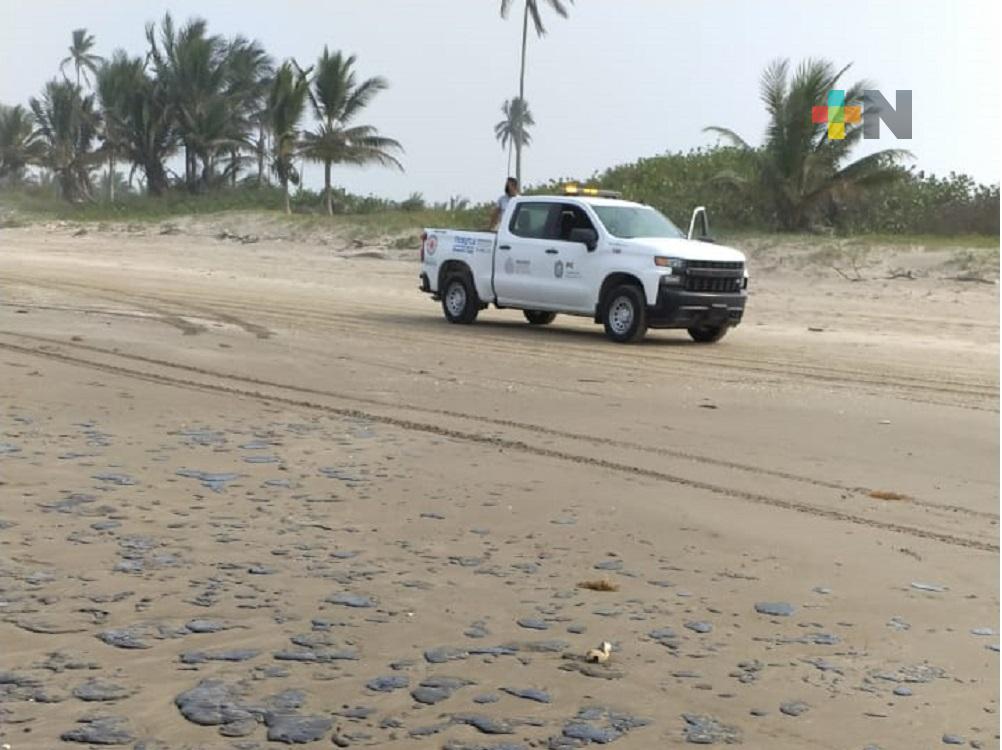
left=421, top=187, right=747, bottom=342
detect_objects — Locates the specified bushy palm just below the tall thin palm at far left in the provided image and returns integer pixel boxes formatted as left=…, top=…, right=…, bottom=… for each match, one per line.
left=29, top=80, right=102, bottom=201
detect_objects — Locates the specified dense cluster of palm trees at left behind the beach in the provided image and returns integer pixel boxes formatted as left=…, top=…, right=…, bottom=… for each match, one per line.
left=0, top=13, right=403, bottom=213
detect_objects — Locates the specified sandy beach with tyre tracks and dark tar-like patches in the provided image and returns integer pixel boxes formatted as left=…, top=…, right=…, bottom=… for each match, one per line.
left=0, top=217, right=999, bottom=750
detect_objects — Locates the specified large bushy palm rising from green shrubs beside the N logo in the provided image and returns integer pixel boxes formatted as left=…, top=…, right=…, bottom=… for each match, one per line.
left=705, top=59, right=911, bottom=229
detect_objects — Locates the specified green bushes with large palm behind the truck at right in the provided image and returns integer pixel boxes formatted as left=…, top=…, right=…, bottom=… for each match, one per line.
left=537, top=59, right=999, bottom=234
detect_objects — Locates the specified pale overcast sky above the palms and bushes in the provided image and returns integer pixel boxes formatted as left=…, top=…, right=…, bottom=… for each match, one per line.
left=0, top=0, right=1002, bottom=200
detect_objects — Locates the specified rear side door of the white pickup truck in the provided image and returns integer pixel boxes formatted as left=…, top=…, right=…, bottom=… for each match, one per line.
left=494, top=200, right=559, bottom=309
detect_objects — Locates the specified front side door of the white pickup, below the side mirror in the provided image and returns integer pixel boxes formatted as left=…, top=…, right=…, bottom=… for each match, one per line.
left=540, top=203, right=598, bottom=312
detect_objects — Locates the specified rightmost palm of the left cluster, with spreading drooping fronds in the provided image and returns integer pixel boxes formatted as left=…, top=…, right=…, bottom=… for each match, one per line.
left=302, top=46, right=404, bottom=214
